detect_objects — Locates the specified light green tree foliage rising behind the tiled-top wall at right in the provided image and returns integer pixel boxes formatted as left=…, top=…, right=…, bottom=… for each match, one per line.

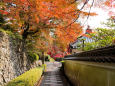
left=76, top=18, right=115, bottom=51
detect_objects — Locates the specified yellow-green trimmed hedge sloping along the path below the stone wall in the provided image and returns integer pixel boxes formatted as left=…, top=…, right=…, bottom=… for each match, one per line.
left=6, top=67, right=43, bottom=86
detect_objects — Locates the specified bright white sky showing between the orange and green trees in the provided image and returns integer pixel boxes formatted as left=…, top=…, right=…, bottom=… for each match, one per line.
left=78, top=0, right=115, bottom=29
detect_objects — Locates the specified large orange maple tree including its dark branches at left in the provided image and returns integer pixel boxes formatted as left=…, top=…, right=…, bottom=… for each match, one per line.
left=2, top=0, right=99, bottom=58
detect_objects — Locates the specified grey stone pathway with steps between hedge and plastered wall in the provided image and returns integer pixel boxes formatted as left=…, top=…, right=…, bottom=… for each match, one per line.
left=40, top=62, right=70, bottom=86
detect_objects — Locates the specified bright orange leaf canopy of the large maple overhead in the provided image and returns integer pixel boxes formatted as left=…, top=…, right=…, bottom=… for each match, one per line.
left=5, top=0, right=96, bottom=52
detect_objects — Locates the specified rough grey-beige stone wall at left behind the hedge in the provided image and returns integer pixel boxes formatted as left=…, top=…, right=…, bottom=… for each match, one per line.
left=0, top=31, right=38, bottom=86
